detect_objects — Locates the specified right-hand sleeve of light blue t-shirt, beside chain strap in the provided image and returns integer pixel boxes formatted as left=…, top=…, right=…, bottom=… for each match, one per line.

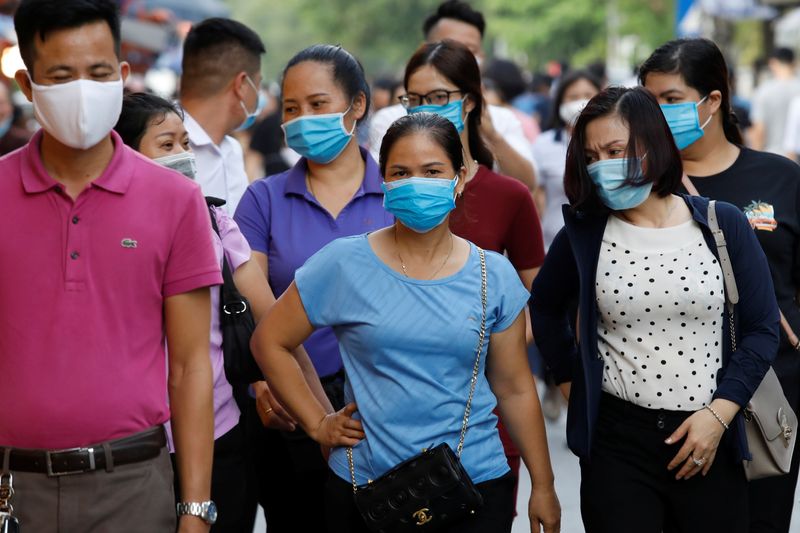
left=486, top=251, right=530, bottom=333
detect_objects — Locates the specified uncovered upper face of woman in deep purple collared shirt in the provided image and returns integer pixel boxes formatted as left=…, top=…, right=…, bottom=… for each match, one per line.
left=283, top=61, right=364, bottom=126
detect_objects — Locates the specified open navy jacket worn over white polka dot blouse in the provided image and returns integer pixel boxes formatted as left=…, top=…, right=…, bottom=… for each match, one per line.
left=530, top=195, right=780, bottom=459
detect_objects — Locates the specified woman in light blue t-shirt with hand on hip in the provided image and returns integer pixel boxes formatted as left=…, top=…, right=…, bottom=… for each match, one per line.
left=254, top=113, right=560, bottom=533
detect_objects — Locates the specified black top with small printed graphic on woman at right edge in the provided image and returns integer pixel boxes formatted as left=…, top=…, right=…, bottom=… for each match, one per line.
left=691, top=148, right=800, bottom=350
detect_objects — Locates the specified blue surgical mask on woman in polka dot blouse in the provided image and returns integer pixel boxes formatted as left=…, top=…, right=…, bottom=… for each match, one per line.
left=586, top=157, right=653, bottom=211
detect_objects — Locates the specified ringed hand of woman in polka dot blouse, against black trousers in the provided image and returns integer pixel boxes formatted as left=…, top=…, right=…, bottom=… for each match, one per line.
left=665, top=409, right=725, bottom=479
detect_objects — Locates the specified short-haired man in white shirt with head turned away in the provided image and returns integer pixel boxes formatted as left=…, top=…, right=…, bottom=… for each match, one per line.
left=180, top=18, right=265, bottom=215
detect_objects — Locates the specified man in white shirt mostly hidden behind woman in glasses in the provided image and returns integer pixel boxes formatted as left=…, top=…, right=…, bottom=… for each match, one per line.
left=369, top=0, right=536, bottom=190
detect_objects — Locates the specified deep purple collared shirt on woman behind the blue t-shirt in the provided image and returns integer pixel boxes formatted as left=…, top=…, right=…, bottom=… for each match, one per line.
left=234, top=149, right=394, bottom=376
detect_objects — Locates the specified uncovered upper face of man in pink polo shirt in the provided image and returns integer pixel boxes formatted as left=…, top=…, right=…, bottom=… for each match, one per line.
left=17, top=21, right=128, bottom=94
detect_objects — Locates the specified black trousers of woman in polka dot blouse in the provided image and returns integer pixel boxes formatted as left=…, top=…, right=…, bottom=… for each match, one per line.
left=581, top=393, right=747, bottom=533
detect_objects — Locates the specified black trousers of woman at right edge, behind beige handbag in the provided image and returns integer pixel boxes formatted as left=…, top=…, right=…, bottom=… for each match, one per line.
left=748, top=350, right=800, bottom=533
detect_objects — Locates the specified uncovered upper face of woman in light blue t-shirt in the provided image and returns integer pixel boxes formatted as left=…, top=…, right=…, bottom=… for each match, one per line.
left=384, top=132, right=466, bottom=193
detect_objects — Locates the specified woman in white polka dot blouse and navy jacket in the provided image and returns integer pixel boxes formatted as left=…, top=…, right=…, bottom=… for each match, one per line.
left=530, top=88, right=779, bottom=533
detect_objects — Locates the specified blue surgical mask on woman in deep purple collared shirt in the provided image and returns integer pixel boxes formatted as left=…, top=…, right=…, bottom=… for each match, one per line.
left=281, top=108, right=356, bottom=165
